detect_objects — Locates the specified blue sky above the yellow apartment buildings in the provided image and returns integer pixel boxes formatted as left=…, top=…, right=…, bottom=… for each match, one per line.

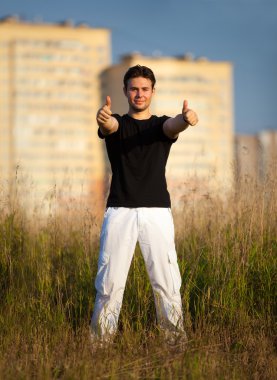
left=0, top=0, right=277, bottom=133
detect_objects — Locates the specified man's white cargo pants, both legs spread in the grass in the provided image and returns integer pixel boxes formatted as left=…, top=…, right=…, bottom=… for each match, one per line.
left=91, top=207, right=183, bottom=337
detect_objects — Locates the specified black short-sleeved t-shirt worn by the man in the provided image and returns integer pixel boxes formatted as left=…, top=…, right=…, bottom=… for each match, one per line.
left=98, top=114, right=177, bottom=207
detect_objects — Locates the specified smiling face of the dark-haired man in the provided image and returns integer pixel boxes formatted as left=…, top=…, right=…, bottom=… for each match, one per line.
left=124, top=77, right=154, bottom=112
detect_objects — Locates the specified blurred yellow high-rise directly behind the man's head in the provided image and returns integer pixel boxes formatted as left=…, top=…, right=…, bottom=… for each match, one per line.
left=102, top=54, right=234, bottom=203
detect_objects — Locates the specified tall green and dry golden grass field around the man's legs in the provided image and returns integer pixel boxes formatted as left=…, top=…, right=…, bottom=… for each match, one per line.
left=0, top=174, right=277, bottom=380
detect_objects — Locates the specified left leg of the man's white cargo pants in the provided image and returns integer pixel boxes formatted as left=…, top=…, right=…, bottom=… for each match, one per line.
left=91, top=207, right=138, bottom=337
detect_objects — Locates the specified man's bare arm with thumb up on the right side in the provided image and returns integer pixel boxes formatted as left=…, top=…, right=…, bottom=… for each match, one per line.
left=163, top=100, right=198, bottom=139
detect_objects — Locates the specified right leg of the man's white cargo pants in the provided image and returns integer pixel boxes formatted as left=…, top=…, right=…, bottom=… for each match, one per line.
left=138, top=208, right=183, bottom=331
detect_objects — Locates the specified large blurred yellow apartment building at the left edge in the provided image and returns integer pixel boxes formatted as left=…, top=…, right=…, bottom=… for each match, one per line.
left=0, top=17, right=111, bottom=211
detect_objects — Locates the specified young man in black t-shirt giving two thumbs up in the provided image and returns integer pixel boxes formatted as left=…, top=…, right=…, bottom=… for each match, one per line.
left=91, top=65, right=198, bottom=340
